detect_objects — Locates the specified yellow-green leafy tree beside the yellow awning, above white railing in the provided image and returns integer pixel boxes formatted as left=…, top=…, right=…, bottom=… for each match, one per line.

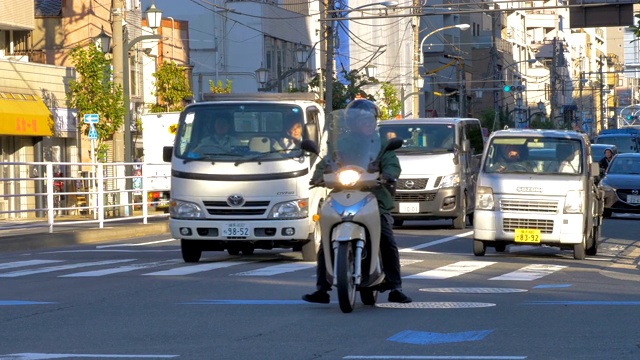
left=67, top=44, right=125, bottom=162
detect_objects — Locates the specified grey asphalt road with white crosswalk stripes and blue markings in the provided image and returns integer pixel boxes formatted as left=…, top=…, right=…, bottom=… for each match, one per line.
left=0, top=218, right=640, bottom=359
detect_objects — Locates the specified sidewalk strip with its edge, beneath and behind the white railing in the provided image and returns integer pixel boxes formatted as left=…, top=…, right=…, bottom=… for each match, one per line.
left=0, top=213, right=170, bottom=252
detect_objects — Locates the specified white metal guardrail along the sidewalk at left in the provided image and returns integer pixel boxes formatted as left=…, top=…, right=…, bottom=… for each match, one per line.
left=0, top=162, right=169, bottom=233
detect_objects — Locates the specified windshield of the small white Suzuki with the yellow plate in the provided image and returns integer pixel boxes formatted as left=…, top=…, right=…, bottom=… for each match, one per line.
left=483, top=137, right=584, bottom=174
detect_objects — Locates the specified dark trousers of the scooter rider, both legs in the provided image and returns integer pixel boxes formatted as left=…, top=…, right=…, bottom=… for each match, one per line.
left=316, top=214, right=402, bottom=291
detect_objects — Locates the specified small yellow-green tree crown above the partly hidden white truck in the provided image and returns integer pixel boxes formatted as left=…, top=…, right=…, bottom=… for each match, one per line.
left=152, top=61, right=192, bottom=112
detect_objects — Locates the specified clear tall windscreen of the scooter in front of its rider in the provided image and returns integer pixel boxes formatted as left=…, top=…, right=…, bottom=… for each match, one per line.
left=328, top=109, right=380, bottom=171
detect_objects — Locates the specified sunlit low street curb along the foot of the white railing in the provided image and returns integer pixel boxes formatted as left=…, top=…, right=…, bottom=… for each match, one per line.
left=0, top=222, right=170, bottom=252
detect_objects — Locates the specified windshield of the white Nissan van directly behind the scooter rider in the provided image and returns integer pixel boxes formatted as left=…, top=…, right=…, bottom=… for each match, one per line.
left=380, top=124, right=455, bottom=153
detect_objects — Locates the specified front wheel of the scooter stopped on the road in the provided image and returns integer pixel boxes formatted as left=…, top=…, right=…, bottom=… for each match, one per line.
left=335, top=242, right=356, bottom=313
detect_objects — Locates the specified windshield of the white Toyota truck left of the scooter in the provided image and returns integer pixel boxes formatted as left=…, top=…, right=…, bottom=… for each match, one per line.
left=175, top=103, right=304, bottom=162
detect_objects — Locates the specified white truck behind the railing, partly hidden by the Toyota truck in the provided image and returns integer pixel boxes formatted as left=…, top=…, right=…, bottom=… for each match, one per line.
left=141, top=112, right=180, bottom=210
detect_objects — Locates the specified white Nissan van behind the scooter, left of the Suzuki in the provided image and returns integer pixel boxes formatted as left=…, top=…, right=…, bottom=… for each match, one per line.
left=379, top=118, right=484, bottom=229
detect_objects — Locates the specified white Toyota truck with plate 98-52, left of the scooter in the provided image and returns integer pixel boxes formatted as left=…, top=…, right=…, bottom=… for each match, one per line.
left=163, top=93, right=327, bottom=262
